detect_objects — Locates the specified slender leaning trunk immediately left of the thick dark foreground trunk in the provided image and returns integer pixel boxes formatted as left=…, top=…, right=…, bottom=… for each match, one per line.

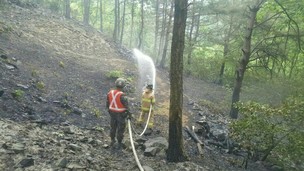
left=159, top=0, right=174, bottom=68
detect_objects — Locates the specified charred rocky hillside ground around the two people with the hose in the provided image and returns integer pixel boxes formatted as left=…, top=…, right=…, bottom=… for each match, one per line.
left=0, top=1, right=267, bottom=171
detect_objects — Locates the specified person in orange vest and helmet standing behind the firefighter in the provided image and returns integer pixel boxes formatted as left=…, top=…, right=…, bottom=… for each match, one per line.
left=107, top=78, right=131, bottom=148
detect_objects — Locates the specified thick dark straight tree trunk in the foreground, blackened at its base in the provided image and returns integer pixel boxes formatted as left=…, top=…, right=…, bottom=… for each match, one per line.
left=167, top=0, right=187, bottom=162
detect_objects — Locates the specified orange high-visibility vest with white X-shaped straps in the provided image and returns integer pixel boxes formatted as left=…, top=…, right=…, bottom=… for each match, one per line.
left=108, top=90, right=127, bottom=113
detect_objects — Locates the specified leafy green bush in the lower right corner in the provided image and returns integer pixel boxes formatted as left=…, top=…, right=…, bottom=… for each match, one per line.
left=230, top=96, right=304, bottom=170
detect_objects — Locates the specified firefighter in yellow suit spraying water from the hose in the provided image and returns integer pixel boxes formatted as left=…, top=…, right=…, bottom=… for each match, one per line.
left=137, top=84, right=155, bottom=129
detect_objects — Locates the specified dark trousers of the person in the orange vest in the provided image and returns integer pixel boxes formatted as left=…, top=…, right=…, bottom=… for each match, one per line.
left=109, top=112, right=127, bottom=143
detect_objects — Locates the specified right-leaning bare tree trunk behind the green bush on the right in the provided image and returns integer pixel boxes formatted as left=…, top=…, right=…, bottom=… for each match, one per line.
left=230, top=0, right=265, bottom=119
